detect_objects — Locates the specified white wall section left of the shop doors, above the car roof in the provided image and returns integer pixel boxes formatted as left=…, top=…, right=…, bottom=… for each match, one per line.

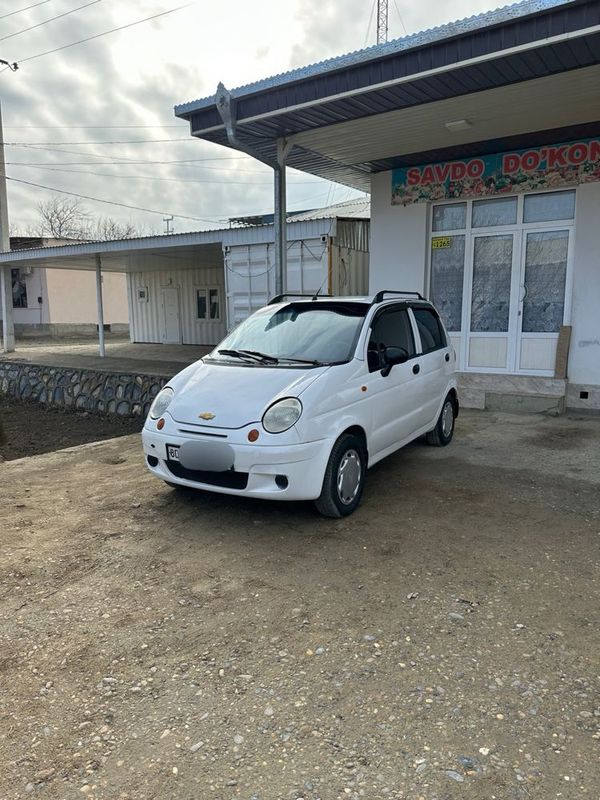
left=369, top=172, right=428, bottom=294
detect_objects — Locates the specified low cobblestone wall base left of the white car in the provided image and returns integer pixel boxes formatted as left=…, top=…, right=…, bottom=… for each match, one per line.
left=0, top=361, right=168, bottom=417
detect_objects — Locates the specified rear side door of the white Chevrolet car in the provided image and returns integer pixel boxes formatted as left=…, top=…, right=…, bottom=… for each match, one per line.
left=411, top=305, right=453, bottom=427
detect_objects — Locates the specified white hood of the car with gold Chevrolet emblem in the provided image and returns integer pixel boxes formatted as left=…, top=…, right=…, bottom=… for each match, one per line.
left=168, top=361, right=330, bottom=428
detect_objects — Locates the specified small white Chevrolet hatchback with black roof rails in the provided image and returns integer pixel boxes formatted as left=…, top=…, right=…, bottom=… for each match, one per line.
left=142, top=291, right=458, bottom=517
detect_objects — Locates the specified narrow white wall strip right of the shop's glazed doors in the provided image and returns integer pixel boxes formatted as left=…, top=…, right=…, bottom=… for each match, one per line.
left=568, top=182, right=600, bottom=386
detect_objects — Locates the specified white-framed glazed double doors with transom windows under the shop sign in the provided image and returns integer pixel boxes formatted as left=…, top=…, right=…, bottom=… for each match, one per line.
left=430, top=190, right=575, bottom=376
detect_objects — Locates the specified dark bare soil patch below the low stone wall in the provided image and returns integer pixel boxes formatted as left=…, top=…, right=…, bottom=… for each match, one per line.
left=0, top=396, right=144, bottom=461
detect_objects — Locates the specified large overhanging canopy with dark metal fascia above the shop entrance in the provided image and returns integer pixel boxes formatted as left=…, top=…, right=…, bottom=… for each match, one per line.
left=175, top=0, right=600, bottom=191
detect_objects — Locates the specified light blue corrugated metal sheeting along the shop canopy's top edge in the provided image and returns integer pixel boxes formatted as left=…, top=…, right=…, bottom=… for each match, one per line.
left=175, top=0, right=576, bottom=115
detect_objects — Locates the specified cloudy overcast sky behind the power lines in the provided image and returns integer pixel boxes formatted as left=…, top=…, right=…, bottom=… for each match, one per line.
left=0, top=0, right=496, bottom=233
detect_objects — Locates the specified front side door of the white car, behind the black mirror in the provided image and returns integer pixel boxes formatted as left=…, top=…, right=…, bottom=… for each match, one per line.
left=366, top=304, right=421, bottom=460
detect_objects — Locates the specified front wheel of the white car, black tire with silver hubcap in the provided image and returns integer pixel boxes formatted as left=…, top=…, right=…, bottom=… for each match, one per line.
left=315, top=433, right=367, bottom=517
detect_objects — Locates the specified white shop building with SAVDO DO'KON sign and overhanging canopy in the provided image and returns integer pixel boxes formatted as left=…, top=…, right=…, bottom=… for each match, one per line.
left=175, top=0, right=600, bottom=409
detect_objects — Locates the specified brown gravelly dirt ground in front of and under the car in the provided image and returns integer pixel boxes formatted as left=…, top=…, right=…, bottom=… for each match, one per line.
left=0, top=412, right=600, bottom=800
